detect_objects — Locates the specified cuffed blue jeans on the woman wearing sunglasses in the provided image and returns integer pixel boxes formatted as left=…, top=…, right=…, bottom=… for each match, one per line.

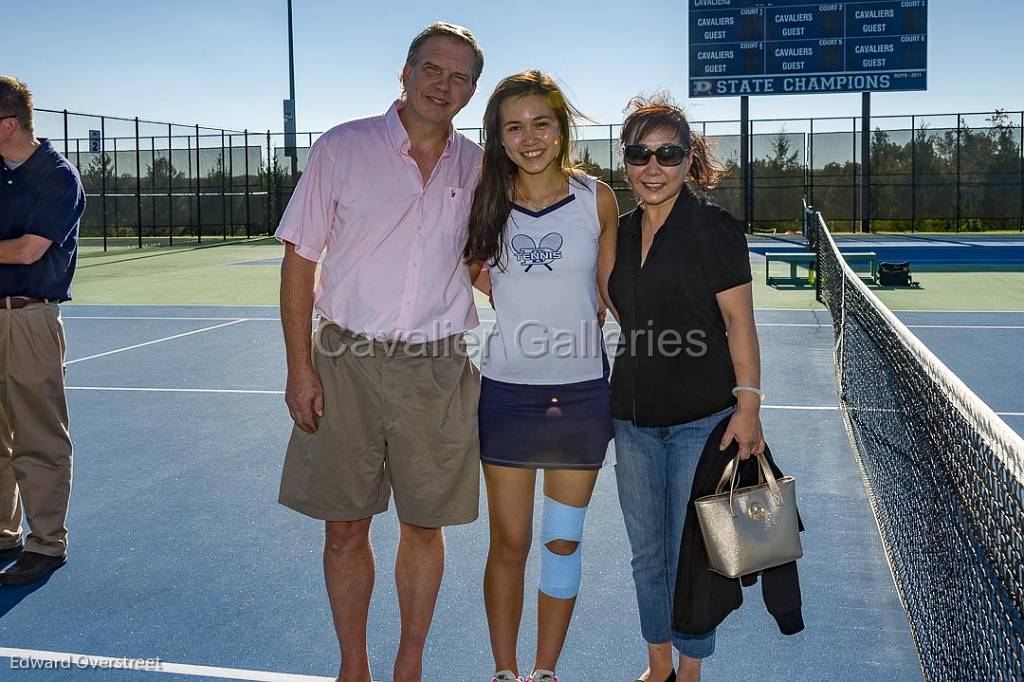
left=614, top=407, right=733, bottom=658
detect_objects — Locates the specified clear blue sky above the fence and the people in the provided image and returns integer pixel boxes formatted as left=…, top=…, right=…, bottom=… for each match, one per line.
left=8, top=0, right=1024, bottom=135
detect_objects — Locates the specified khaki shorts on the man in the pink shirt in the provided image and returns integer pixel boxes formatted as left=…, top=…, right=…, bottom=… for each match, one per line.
left=280, top=321, right=480, bottom=527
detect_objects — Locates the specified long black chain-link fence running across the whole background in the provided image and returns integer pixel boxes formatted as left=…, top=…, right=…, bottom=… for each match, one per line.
left=36, top=110, right=1024, bottom=249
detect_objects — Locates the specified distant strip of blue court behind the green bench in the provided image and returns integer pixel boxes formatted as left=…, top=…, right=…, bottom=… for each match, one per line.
left=749, top=232, right=1024, bottom=267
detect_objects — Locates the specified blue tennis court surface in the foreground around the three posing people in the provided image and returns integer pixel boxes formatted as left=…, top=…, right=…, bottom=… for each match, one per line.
left=0, top=305, right=1024, bottom=682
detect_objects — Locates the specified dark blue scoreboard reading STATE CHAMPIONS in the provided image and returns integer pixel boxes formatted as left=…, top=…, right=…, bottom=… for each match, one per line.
left=689, top=0, right=928, bottom=97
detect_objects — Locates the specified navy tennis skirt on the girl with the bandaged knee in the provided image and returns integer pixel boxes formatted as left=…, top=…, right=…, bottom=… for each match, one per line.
left=479, top=366, right=612, bottom=469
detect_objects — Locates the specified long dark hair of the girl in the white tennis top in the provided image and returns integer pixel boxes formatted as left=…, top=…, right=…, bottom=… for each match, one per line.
left=463, top=69, right=587, bottom=266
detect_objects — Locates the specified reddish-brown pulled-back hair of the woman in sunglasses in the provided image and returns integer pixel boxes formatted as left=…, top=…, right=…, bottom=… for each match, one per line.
left=620, top=91, right=725, bottom=197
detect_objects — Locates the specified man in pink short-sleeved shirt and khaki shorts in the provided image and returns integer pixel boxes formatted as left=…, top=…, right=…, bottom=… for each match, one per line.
left=276, top=23, right=483, bottom=682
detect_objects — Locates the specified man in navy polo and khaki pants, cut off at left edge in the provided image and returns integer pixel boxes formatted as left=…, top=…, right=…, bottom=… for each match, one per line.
left=0, top=76, right=85, bottom=585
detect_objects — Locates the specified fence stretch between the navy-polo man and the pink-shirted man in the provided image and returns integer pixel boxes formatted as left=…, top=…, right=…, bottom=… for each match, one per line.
left=35, top=110, right=272, bottom=251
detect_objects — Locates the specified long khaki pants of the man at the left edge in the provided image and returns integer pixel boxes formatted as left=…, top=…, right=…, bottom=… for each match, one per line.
left=0, top=303, right=72, bottom=556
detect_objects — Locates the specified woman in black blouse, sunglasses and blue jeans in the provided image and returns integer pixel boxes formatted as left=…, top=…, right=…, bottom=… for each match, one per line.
left=609, top=97, right=764, bottom=682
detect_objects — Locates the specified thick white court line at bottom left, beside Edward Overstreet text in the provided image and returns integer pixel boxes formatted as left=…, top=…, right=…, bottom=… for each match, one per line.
left=0, top=647, right=334, bottom=682
